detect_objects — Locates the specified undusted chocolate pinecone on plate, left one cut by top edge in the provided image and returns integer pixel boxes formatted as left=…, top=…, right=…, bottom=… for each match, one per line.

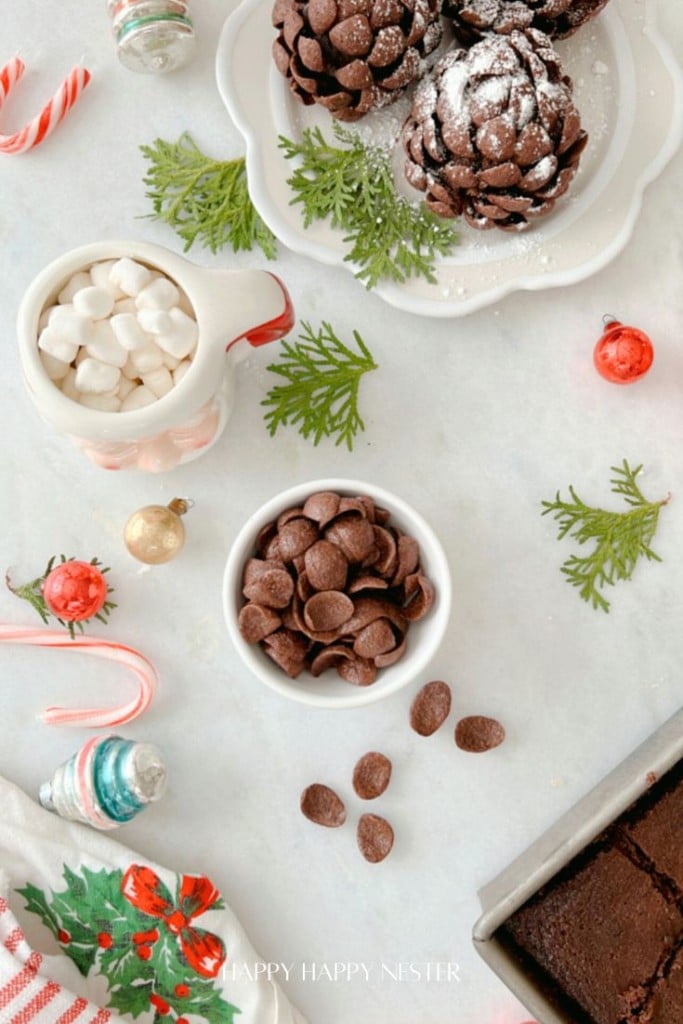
left=272, top=0, right=442, bottom=121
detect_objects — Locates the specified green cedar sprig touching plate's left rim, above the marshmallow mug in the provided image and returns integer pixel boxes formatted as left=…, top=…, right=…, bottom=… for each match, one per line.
left=140, top=132, right=276, bottom=259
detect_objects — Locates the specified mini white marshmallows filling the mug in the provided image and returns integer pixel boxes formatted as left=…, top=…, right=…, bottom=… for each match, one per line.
left=38, top=257, right=199, bottom=413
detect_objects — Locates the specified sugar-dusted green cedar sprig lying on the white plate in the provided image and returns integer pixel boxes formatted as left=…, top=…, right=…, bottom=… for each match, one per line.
left=280, top=124, right=458, bottom=289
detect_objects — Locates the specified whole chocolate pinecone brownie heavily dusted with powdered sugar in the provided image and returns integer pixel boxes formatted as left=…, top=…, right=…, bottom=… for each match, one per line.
left=401, top=29, right=588, bottom=231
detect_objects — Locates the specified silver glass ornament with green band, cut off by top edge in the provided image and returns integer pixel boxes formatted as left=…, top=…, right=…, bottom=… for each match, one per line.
left=106, top=0, right=195, bottom=74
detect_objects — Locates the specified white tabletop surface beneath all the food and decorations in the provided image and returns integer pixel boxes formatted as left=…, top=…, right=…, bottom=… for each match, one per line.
left=0, top=0, right=683, bottom=1024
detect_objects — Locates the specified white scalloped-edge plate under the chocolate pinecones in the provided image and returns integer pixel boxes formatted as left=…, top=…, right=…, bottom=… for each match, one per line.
left=216, top=0, right=683, bottom=316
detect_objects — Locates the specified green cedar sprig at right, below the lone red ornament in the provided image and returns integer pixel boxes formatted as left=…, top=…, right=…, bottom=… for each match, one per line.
left=541, top=459, right=670, bottom=611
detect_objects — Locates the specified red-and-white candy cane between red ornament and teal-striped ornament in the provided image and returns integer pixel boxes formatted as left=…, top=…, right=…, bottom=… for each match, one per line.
left=0, top=623, right=158, bottom=729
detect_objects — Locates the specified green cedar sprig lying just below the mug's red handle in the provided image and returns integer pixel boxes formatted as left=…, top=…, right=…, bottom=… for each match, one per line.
left=261, top=321, right=377, bottom=452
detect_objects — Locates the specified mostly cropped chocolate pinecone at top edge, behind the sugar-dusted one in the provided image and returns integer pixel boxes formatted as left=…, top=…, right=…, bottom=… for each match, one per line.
left=443, top=0, right=607, bottom=46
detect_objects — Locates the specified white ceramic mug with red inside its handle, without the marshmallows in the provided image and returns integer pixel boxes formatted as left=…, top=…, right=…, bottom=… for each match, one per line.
left=17, top=241, right=294, bottom=472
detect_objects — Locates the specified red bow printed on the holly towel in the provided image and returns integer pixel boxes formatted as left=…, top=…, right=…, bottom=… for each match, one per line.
left=121, top=864, right=225, bottom=978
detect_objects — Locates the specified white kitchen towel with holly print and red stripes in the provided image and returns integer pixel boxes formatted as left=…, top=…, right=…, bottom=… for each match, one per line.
left=0, top=777, right=306, bottom=1024
